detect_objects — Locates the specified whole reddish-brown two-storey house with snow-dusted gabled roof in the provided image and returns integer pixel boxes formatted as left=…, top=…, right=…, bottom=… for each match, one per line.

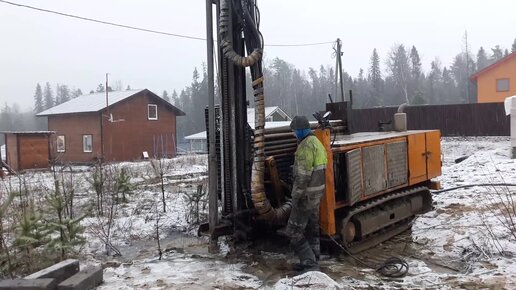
left=37, top=89, right=185, bottom=163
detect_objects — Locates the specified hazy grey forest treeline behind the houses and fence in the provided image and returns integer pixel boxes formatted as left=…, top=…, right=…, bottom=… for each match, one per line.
left=0, top=39, right=516, bottom=143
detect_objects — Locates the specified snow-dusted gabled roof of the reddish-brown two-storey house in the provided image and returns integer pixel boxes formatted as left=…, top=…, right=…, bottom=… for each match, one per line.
left=36, top=89, right=185, bottom=117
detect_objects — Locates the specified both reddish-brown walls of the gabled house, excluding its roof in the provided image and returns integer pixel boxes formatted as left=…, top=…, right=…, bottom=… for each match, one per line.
left=48, top=92, right=177, bottom=162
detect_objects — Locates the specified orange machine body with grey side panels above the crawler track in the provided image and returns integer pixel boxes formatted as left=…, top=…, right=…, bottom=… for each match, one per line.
left=315, top=130, right=441, bottom=235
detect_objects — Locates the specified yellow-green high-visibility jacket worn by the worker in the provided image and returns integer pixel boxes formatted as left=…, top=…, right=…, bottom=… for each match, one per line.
left=292, top=134, right=328, bottom=199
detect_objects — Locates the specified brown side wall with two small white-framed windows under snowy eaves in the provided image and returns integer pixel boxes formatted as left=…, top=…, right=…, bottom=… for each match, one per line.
left=48, top=113, right=102, bottom=163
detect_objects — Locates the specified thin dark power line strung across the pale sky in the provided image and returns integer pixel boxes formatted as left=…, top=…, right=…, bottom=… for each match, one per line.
left=0, top=0, right=335, bottom=47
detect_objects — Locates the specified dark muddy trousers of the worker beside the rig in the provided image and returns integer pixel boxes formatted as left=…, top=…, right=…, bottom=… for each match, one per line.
left=286, top=192, right=323, bottom=258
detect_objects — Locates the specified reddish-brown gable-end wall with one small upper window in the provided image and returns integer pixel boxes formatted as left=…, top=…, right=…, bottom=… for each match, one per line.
left=103, top=94, right=176, bottom=161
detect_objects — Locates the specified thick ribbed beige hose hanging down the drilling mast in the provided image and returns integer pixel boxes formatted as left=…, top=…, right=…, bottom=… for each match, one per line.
left=219, top=0, right=292, bottom=225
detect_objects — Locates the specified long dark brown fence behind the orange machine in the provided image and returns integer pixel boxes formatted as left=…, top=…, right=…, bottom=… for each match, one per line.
left=351, top=103, right=510, bottom=136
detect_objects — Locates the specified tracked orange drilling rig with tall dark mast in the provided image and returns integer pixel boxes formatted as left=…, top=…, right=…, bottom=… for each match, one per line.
left=199, top=0, right=441, bottom=253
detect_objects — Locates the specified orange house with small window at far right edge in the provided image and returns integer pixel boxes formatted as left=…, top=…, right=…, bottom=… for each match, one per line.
left=471, top=52, right=516, bottom=103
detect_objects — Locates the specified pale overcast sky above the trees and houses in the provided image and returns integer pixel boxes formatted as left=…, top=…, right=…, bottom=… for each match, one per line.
left=0, top=0, right=516, bottom=110
